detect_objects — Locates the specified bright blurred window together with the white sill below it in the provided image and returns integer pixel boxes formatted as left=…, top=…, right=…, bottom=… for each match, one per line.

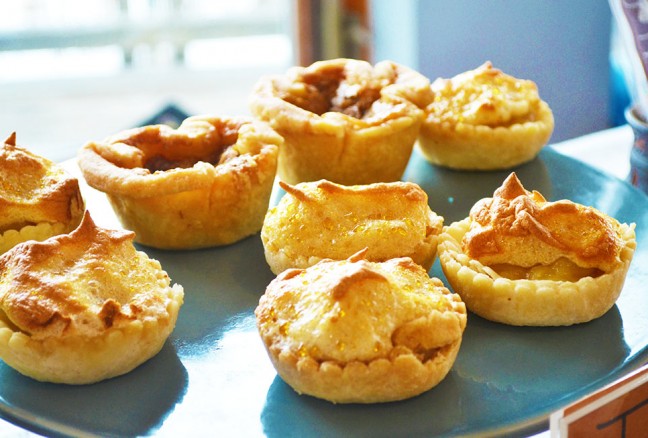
left=0, top=0, right=294, bottom=161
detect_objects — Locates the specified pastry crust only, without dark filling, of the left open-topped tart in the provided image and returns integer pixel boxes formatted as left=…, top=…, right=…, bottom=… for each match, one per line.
left=78, top=116, right=283, bottom=249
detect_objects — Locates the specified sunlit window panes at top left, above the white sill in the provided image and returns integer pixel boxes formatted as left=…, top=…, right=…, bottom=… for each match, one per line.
left=0, top=0, right=293, bottom=82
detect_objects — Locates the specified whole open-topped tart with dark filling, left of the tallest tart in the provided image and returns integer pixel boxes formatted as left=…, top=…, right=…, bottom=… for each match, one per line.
left=78, top=116, right=283, bottom=249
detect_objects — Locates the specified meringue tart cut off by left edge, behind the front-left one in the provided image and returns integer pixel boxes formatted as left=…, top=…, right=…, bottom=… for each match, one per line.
left=0, top=133, right=85, bottom=254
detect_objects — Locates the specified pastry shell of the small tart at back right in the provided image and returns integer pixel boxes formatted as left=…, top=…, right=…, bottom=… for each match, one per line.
left=417, top=101, right=554, bottom=170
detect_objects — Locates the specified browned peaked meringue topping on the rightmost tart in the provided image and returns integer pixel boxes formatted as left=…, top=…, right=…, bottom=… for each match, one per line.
left=462, top=172, right=624, bottom=272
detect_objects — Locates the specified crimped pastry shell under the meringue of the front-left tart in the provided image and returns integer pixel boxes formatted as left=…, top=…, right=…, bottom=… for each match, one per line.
left=0, top=285, right=183, bottom=385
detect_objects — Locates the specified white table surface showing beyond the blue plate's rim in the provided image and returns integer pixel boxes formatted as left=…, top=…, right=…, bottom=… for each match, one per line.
left=0, top=125, right=633, bottom=438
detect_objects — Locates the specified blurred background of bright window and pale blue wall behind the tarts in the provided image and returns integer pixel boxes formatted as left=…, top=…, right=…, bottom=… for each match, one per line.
left=0, top=0, right=627, bottom=161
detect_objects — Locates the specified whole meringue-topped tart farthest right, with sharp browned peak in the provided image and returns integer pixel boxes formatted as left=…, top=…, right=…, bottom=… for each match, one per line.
left=438, top=173, right=636, bottom=326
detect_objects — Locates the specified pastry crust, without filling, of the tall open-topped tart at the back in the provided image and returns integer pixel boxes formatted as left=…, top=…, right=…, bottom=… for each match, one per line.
left=250, top=59, right=429, bottom=185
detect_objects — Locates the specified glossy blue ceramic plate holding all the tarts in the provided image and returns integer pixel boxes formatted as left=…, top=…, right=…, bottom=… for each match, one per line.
left=0, top=148, right=648, bottom=437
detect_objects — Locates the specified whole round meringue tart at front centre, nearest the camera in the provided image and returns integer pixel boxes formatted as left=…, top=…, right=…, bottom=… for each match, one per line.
left=255, top=252, right=466, bottom=403
